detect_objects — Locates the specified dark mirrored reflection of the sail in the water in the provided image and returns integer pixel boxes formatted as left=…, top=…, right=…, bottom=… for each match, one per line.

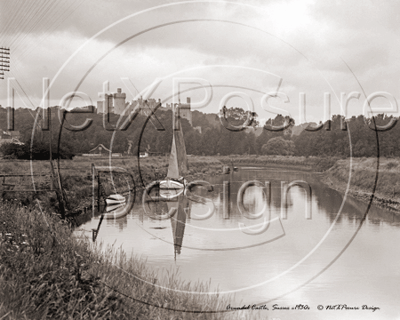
left=167, top=195, right=190, bottom=254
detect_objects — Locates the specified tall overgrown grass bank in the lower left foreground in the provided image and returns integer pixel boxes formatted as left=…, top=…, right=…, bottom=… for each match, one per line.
left=0, top=202, right=260, bottom=319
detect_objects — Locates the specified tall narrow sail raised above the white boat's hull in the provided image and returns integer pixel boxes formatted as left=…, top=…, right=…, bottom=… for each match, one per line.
left=167, top=106, right=188, bottom=179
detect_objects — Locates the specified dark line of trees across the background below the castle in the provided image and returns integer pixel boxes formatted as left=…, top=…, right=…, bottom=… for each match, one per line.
left=0, top=107, right=400, bottom=160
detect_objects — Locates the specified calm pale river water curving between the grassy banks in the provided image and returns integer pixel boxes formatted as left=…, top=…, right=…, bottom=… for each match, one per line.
left=76, top=168, right=400, bottom=320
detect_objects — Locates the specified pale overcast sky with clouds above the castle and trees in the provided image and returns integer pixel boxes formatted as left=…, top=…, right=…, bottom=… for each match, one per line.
left=0, top=0, right=400, bottom=123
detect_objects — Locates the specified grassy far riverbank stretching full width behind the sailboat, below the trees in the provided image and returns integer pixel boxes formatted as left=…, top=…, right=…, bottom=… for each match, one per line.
left=0, top=155, right=400, bottom=216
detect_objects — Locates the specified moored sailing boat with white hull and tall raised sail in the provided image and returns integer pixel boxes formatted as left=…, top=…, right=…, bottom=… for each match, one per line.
left=160, top=104, right=188, bottom=199
